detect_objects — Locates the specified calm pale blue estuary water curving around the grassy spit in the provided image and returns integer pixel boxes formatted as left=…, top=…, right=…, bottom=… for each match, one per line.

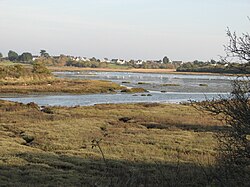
left=0, top=71, right=236, bottom=106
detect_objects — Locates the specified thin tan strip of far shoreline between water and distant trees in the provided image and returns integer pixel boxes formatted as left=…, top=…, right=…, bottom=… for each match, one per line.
left=48, top=66, right=237, bottom=76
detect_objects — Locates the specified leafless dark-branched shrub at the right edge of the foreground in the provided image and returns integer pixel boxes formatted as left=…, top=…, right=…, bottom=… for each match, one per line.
left=194, top=25, right=250, bottom=186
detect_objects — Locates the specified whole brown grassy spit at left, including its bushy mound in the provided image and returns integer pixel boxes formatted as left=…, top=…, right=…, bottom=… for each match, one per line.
left=0, top=63, right=123, bottom=94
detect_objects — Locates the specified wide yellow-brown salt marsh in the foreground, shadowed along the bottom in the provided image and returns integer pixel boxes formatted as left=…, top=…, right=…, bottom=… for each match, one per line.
left=0, top=101, right=223, bottom=186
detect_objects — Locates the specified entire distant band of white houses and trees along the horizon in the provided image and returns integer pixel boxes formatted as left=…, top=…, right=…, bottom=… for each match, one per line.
left=0, top=50, right=239, bottom=73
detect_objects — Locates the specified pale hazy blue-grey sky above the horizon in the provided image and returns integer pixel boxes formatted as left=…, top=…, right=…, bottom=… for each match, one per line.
left=0, top=0, right=250, bottom=61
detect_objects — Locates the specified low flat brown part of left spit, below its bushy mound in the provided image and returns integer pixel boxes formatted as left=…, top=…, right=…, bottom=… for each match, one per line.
left=0, top=79, right=123, bottom=94
